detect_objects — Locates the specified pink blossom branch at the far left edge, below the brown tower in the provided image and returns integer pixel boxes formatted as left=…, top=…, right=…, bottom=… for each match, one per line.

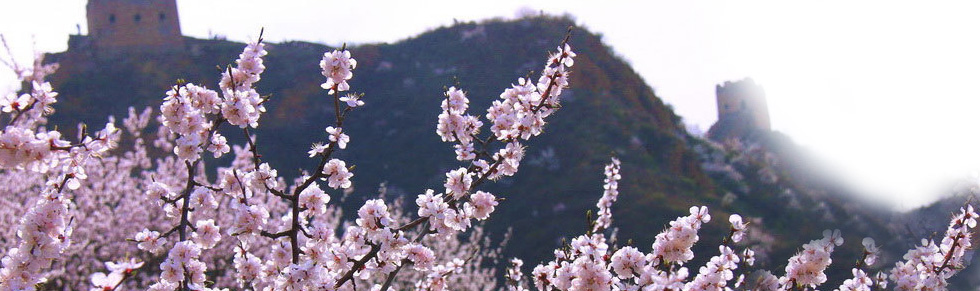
left=0, top=48, right=119, bottom=290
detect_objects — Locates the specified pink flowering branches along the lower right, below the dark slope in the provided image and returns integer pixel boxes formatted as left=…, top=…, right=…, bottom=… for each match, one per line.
left=507, top=158, right=978, bottom=290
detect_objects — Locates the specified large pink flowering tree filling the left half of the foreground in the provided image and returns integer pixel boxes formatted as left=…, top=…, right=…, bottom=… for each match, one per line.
left=0, top=28, right=574, bottom=290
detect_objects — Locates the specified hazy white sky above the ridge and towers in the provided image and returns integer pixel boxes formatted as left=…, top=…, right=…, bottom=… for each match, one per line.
left=0, top=0, right=980, bottom=208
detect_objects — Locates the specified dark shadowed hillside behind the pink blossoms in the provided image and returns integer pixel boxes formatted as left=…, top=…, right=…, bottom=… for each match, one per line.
left=42, top=16, right=924, bottom=284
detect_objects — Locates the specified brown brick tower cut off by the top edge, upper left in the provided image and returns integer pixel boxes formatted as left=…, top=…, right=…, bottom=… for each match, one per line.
left=85, top=0, right=184, bottom=51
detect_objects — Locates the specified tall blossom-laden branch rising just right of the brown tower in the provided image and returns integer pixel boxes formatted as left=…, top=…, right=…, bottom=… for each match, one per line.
left=141, top=38, right=278, bottom=290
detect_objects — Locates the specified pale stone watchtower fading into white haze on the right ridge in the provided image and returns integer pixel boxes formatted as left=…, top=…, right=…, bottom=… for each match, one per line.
left=708, top=78, right=771, bottom=140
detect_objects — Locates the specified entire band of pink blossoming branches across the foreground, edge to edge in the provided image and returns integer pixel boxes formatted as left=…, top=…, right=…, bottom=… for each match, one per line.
left=0, top=26, right=977, bottom=290
